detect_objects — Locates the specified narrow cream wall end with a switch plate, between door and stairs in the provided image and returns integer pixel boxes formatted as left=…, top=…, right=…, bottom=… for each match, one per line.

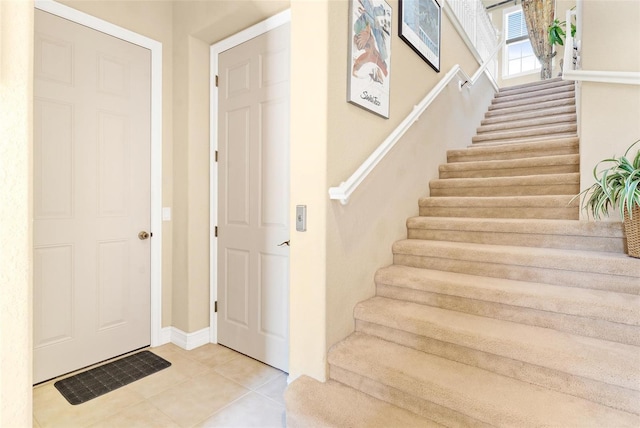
left=289, top=0, right=330, bottom=380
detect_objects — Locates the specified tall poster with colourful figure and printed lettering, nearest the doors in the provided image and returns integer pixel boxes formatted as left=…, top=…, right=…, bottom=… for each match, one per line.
left=347, top=0, right=391, bottom=119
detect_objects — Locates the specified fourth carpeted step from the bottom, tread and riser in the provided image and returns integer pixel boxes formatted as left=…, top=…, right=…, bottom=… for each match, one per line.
left=376, top=266, right=640, bottom=348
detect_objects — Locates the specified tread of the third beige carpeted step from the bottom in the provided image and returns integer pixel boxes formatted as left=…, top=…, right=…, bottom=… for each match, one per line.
left=354, top=297, right=640, bottom=390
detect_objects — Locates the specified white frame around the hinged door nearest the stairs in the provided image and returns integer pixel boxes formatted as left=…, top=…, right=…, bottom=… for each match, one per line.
left=209, top=9, right=291, bottom=343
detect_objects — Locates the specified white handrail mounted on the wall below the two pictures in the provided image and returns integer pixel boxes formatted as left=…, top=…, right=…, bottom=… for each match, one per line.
left=329, top=43, right=502, bottom=205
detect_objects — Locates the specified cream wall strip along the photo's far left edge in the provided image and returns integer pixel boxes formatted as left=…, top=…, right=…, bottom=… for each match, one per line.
left=0, top=1, right=33, bottom=427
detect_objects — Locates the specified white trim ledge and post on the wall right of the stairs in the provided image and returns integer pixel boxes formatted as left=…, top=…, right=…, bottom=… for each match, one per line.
left=562, top=10, right=640, bottom=85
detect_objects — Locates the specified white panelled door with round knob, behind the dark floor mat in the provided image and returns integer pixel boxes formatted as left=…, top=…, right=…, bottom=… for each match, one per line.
left=34, top=10, right=151, bottom=383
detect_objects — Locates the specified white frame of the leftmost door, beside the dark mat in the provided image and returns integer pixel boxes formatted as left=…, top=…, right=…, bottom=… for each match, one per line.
left=35, top=0, right=163, bottom=346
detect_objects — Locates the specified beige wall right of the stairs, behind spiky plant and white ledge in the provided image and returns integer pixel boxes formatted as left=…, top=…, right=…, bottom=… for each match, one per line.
left=580, top=0, right=640, bottom=217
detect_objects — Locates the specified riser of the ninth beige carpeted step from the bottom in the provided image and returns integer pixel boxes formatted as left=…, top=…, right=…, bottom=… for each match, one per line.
left=440, top=164, right=579, bottom=179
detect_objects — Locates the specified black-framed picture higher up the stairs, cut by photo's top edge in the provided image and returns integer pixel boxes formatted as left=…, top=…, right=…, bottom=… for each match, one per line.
left=398, top=0, right=441, bottom=72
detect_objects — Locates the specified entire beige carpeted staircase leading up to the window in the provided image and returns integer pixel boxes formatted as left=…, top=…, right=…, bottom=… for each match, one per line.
left=285, top=79, right=640, bottom=427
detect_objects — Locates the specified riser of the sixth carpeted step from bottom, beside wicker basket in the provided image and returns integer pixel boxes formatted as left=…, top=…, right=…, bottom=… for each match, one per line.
left=407, top=228, right=625, bottom=253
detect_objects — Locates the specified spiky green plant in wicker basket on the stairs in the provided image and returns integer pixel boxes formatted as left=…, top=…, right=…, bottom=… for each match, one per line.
left=576, top=140, right=640, bottom=258
